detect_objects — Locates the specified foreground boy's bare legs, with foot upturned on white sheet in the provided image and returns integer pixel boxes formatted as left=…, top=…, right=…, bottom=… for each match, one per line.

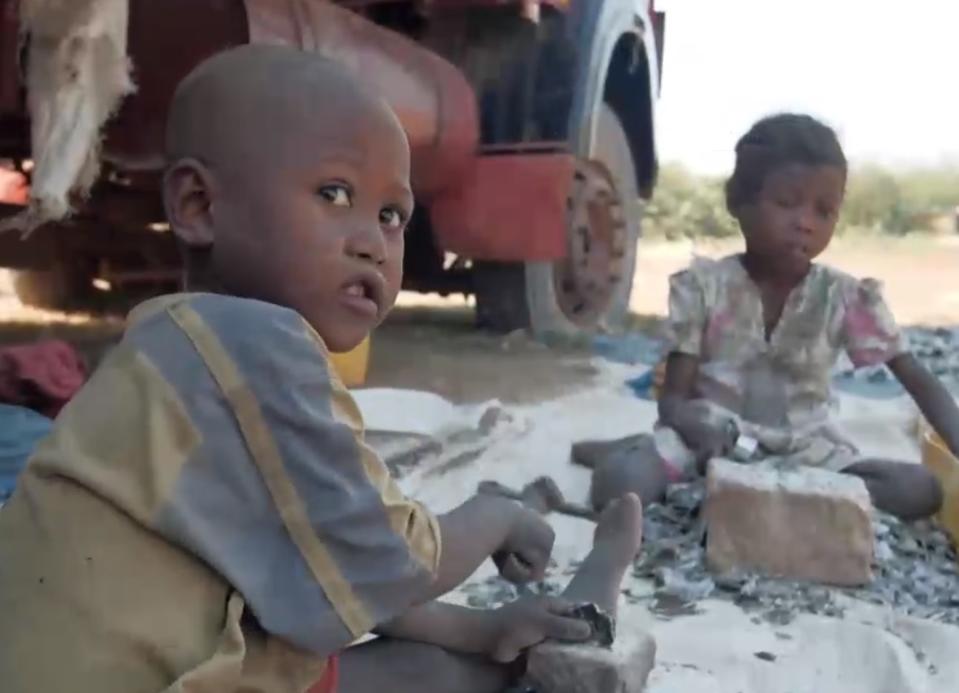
left=340, top=496, right=643, bottom=693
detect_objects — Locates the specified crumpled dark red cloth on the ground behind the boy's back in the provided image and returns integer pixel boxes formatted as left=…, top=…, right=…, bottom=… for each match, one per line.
left=0, top=340, right=87, bottom=419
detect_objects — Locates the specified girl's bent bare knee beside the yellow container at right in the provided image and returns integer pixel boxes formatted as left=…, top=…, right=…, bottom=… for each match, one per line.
left=842, top=459, right=942, bottom=520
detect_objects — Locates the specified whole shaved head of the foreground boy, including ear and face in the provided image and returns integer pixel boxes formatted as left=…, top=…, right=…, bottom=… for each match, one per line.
left=163, top=46, right=413, bottom=350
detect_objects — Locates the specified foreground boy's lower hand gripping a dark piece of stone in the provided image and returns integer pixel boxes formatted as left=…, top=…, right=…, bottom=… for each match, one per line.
left=488, top=597, right=592, bottom=664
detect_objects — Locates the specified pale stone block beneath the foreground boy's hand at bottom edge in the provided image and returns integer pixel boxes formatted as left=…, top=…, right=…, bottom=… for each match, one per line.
left=525, top=632, right=656, bottom=693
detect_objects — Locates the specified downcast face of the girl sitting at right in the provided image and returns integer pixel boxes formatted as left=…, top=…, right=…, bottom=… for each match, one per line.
left=738, top=164, right=846, bottom=278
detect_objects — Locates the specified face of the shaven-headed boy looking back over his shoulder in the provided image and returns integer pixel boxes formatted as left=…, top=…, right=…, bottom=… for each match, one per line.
left=209, top=97, right=413, bottom=351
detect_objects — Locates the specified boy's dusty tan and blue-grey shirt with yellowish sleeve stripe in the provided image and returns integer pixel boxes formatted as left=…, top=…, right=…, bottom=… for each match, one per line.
left=0, top=294, right=440, bottom=693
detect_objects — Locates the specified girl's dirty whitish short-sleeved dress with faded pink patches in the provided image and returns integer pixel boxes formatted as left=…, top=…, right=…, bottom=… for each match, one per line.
left=655, top=255, right=907, bottom=473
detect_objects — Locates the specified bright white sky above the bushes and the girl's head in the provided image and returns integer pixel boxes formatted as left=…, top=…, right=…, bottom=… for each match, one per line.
left=655, top=0, right=959, bottom=174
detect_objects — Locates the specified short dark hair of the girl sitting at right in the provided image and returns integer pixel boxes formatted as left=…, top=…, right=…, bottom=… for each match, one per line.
left=726, top=113, right=847, bottom=216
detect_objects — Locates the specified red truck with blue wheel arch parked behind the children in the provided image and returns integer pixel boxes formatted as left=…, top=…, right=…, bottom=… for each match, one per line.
left=0, top=0, right=664, bottom=334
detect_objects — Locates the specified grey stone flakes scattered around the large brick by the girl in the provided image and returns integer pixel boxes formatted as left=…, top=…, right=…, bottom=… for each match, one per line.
left=464, top=480, right=959, bottom=625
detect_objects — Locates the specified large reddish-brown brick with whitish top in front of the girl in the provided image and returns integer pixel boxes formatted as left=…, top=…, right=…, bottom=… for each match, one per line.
left=705, top=460, right=875, bottom=586
